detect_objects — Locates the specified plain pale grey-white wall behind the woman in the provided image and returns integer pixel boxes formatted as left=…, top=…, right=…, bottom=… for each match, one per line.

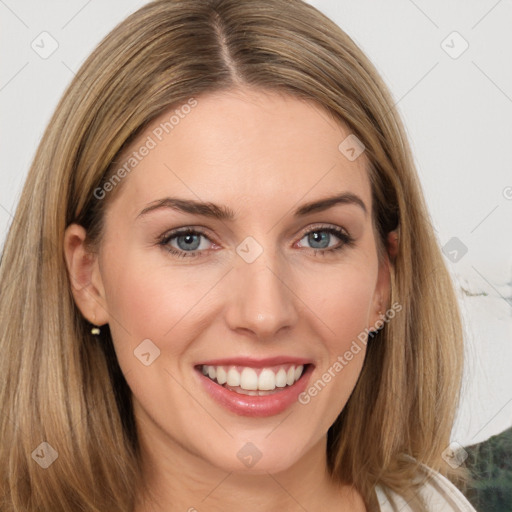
left=0, top=0, right=512, bottom=445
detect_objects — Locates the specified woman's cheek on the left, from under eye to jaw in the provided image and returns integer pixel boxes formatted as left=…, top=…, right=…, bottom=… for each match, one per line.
left=99, top=257, right=219, bottom=420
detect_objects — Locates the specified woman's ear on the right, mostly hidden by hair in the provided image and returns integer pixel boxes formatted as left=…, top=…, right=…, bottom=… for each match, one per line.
left=368, top=230, right=398, bottom=331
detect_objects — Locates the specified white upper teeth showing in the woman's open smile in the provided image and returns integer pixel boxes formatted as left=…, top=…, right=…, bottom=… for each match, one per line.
left=195, top=363, right=310, bottom=396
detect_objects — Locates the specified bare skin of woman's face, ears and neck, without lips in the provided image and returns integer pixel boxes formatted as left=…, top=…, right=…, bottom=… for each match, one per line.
left=65, top=88, right=396, bottom=512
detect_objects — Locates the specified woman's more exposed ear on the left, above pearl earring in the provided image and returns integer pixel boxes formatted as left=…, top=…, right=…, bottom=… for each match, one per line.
left=64, top=224, right=109, bottom=326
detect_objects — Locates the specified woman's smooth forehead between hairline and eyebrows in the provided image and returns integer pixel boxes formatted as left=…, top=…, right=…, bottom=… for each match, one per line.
left=111, top=89, right=371, bottom=216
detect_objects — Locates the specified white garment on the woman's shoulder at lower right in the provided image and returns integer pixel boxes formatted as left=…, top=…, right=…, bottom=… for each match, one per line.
left=375, top=466, right=476, bottom=512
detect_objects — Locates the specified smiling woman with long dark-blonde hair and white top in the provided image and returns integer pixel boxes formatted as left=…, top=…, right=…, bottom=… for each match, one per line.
left=0, top=0, right=478, bottom=512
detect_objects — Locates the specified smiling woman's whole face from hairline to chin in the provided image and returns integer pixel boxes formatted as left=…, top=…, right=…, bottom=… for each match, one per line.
left=67, top=89, right=388, bottom=472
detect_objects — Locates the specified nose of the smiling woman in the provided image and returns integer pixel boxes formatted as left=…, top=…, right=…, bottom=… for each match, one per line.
left=226, top=249, right=300, bottom=340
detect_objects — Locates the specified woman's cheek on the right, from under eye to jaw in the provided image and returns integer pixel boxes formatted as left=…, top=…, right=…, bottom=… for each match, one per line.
left=290, top=260, right=376, bottom=431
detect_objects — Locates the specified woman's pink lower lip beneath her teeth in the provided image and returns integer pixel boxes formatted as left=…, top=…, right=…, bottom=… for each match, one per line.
left=196, top=364, right=313, bottom=418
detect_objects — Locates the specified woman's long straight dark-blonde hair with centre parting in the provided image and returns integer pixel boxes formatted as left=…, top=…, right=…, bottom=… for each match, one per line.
left=0, top=0, right=463, bottom=512
